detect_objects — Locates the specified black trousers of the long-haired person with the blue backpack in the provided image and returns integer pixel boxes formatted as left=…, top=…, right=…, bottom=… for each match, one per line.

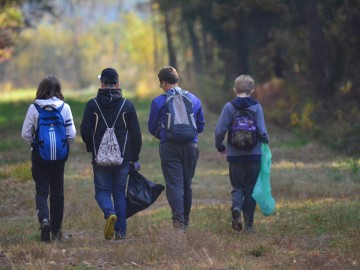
left=31, top=151, right=65, bottom=233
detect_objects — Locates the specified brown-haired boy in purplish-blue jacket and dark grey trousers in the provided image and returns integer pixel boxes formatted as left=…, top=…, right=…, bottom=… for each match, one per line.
left=148, top=66, right=205, bottom=232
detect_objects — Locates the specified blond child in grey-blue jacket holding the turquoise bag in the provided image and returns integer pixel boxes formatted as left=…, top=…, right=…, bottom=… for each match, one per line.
left=215, top=75, right=269, bottom=232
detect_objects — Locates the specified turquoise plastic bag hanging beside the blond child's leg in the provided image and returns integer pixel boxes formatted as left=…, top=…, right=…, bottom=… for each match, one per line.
left=252, top=143, right=275, bottom=216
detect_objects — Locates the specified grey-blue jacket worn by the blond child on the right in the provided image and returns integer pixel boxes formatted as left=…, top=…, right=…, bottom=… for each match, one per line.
left=215, top=97, right=269, bottom=162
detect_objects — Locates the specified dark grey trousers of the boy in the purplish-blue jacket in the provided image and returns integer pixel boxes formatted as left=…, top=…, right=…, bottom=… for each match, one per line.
left=160, top=142, right=199, bottom=226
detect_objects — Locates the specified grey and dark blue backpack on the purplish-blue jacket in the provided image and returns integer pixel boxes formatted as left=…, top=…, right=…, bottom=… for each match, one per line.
left=163, top=90, right=197, bottom=143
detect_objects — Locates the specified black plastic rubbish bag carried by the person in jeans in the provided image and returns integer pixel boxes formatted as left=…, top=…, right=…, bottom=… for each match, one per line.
left=126, top=170, right=165, bottom=218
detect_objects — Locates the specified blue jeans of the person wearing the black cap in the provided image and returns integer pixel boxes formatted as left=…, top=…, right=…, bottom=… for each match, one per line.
left=93, top=161, right=130, bottom=235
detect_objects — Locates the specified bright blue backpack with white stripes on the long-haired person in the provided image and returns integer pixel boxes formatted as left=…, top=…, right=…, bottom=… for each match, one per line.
left=33, top=103, right=69, bottom=161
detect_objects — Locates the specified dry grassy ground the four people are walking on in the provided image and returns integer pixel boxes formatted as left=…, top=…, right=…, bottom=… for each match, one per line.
left=0, top=91, right=360, bottom=269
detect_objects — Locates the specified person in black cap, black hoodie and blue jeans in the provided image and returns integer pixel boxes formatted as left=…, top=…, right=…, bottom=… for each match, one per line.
left=80, top=68, right=142, bottom=240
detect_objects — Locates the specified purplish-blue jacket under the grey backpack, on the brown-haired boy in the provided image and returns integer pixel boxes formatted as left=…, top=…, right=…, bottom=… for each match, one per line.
left=148, top=87, right=205, bottom=143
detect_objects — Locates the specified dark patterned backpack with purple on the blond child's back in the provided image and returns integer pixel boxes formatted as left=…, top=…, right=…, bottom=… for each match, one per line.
left=228, top=103, right=257, bottom=150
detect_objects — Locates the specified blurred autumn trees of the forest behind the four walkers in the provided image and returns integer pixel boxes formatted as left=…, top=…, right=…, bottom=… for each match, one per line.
left=0, top=0, right=360, bottom=155
